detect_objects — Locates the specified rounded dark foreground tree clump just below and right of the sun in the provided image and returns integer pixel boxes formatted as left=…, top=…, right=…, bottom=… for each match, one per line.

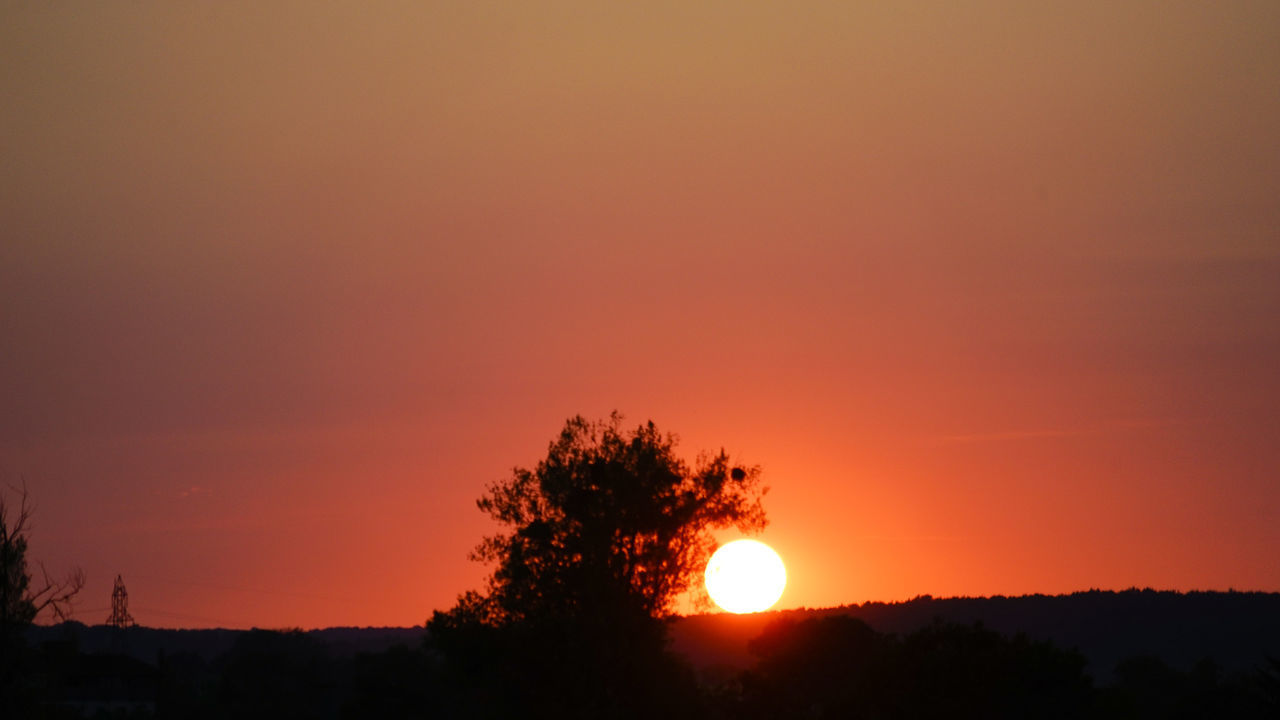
left=724, top=615, right=1092, bottom=720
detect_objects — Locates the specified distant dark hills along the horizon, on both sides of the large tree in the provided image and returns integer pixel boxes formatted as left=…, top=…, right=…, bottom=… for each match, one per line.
left=28, top=589, right=1280, bottom=683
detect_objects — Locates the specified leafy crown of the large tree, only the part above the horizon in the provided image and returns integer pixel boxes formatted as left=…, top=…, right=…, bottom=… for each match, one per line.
left=461, top=413, right=767, bottom=623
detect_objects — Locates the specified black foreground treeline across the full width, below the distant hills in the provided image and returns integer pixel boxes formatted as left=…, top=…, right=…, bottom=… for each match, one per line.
left=5, top=615, right=1280, bottom=720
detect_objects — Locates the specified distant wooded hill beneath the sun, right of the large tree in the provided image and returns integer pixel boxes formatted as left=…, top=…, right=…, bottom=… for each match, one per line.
left=671, top=589, right=1280, bottom=682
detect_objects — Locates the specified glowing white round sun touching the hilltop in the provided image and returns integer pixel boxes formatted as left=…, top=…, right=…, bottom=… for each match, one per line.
left=707, top=539, right=787, bottom=612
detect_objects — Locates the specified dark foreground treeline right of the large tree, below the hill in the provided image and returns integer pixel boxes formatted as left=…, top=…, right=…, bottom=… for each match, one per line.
left=724, top=615, right=1280, bottom=719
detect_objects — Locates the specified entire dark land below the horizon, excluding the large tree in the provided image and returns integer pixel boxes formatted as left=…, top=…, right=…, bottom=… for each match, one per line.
left=12, top=589, right=1280, bottom=720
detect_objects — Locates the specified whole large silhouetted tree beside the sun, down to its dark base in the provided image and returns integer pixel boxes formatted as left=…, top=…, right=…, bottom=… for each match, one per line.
left=429, top=413, right=765, bottom=717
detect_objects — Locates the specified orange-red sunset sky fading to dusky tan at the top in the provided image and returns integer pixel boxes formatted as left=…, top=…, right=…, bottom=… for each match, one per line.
left=0, top=0, right=1280, bottom=628
